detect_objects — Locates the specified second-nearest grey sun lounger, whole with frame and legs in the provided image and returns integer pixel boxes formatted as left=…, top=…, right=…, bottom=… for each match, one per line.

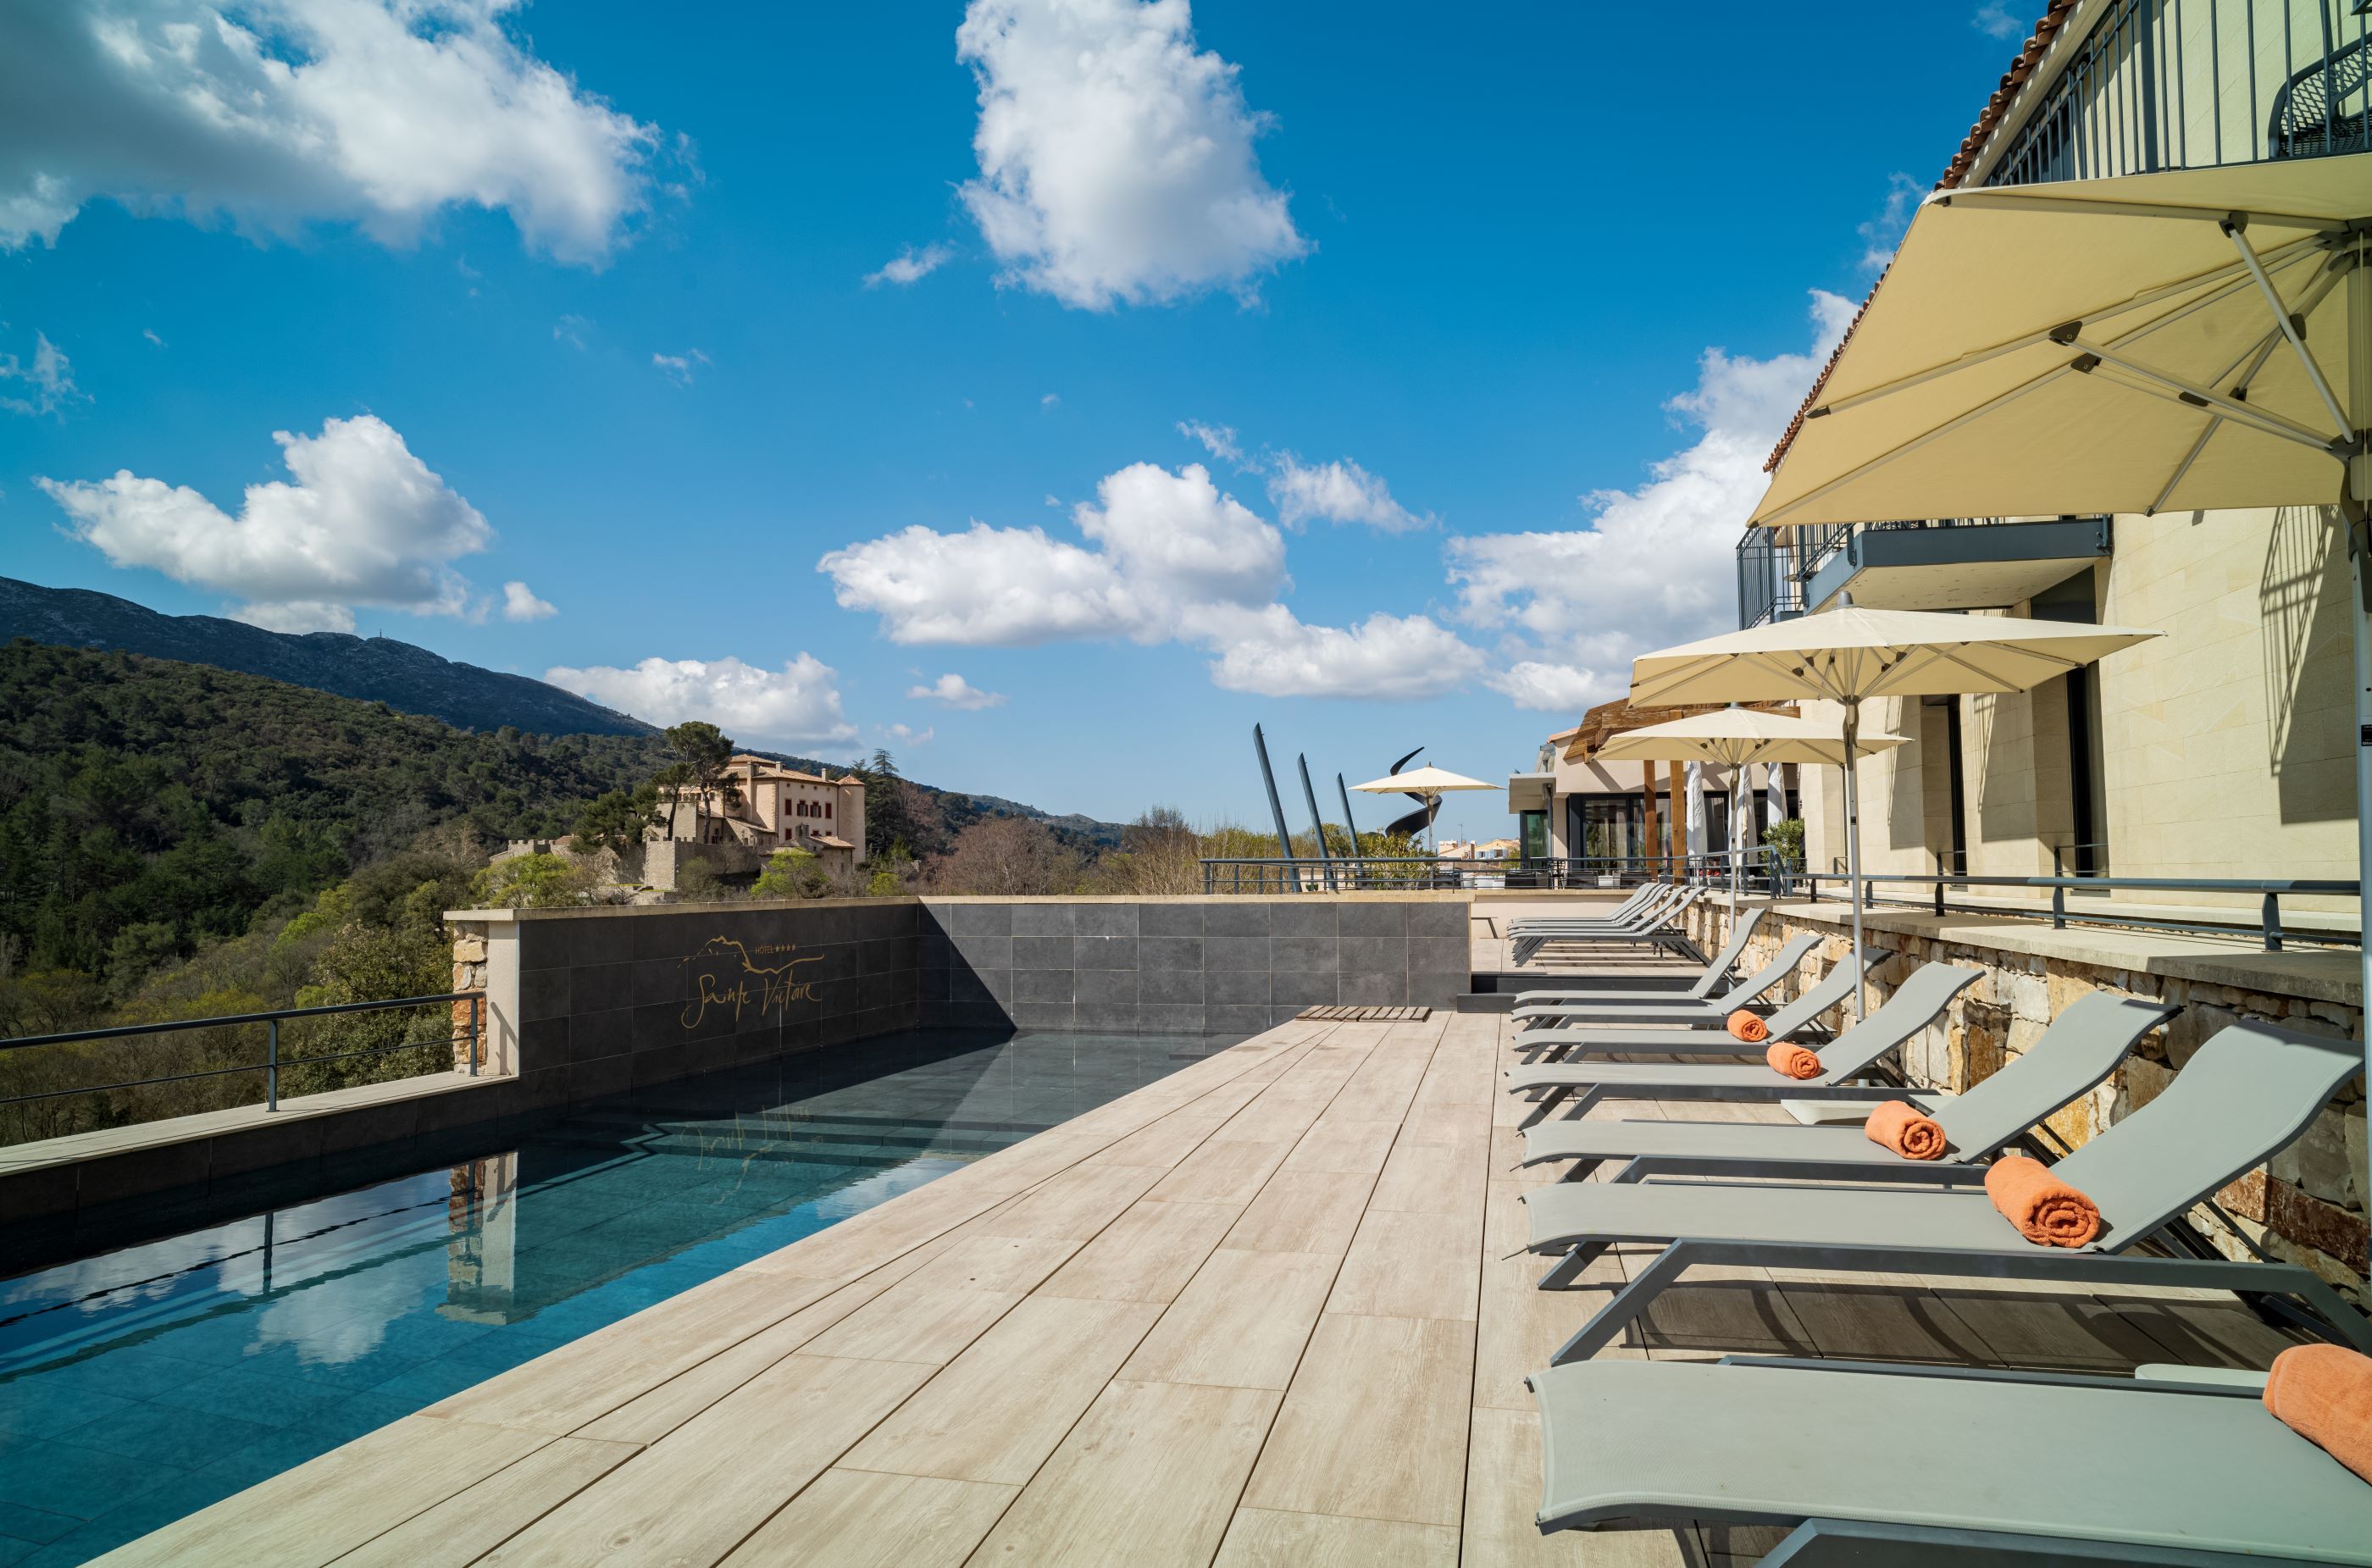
left=1525, top=1022, right=2372, bottom=1366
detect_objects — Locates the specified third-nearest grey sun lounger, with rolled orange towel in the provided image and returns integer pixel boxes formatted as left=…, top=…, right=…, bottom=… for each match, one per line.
left=1523, top=992, right=2182, bottom=1183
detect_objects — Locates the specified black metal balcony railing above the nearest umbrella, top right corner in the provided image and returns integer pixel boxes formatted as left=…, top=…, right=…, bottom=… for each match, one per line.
left=1983, top=0, right=2372, bottom=185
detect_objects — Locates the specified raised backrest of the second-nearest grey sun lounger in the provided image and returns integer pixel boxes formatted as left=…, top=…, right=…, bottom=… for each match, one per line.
left=2057, top=1022, right=2365, bottom=1253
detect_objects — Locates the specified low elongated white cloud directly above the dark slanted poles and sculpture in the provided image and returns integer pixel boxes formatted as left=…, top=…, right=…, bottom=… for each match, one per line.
left=1193, top=605, right=1482, bottom=697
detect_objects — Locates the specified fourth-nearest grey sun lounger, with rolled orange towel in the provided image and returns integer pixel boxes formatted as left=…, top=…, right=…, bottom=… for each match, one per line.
left=1506, top=958, right=1981, bottom=1127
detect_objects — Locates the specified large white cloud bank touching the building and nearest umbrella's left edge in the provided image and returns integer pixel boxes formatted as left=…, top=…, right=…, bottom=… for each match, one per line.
left=1449, top=290, right=1853, bottom=712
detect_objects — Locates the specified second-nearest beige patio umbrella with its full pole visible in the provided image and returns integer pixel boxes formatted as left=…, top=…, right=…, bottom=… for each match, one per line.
left=1630, top=605, right=2159, bottom=1017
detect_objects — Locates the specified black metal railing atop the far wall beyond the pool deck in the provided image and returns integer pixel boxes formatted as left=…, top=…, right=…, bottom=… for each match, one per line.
left=1203, top=850, right=1788, bottom=895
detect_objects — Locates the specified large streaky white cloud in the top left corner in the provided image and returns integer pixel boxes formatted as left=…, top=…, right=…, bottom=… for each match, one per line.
left=0, top=0, right=659, bottom=263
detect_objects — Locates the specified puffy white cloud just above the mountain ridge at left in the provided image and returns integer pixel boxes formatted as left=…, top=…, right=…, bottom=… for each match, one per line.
left=36, top=413, right=493, bottom=631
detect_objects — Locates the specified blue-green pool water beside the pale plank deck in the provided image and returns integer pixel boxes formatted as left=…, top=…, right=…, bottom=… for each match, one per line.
left=0, top=1032, right=1224, bottom=1568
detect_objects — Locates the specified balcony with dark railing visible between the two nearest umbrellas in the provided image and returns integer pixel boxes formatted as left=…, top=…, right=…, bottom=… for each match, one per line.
left=1738, top=517, right=2114, bottom=626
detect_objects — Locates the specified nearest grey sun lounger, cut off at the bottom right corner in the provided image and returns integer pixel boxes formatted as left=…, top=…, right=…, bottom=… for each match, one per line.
left=1530, top=1361, right=2372, bottom=1568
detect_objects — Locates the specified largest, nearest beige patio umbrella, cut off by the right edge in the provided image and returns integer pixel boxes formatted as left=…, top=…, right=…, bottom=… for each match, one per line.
left=1753, top=152, right=2372, bottom=1186
